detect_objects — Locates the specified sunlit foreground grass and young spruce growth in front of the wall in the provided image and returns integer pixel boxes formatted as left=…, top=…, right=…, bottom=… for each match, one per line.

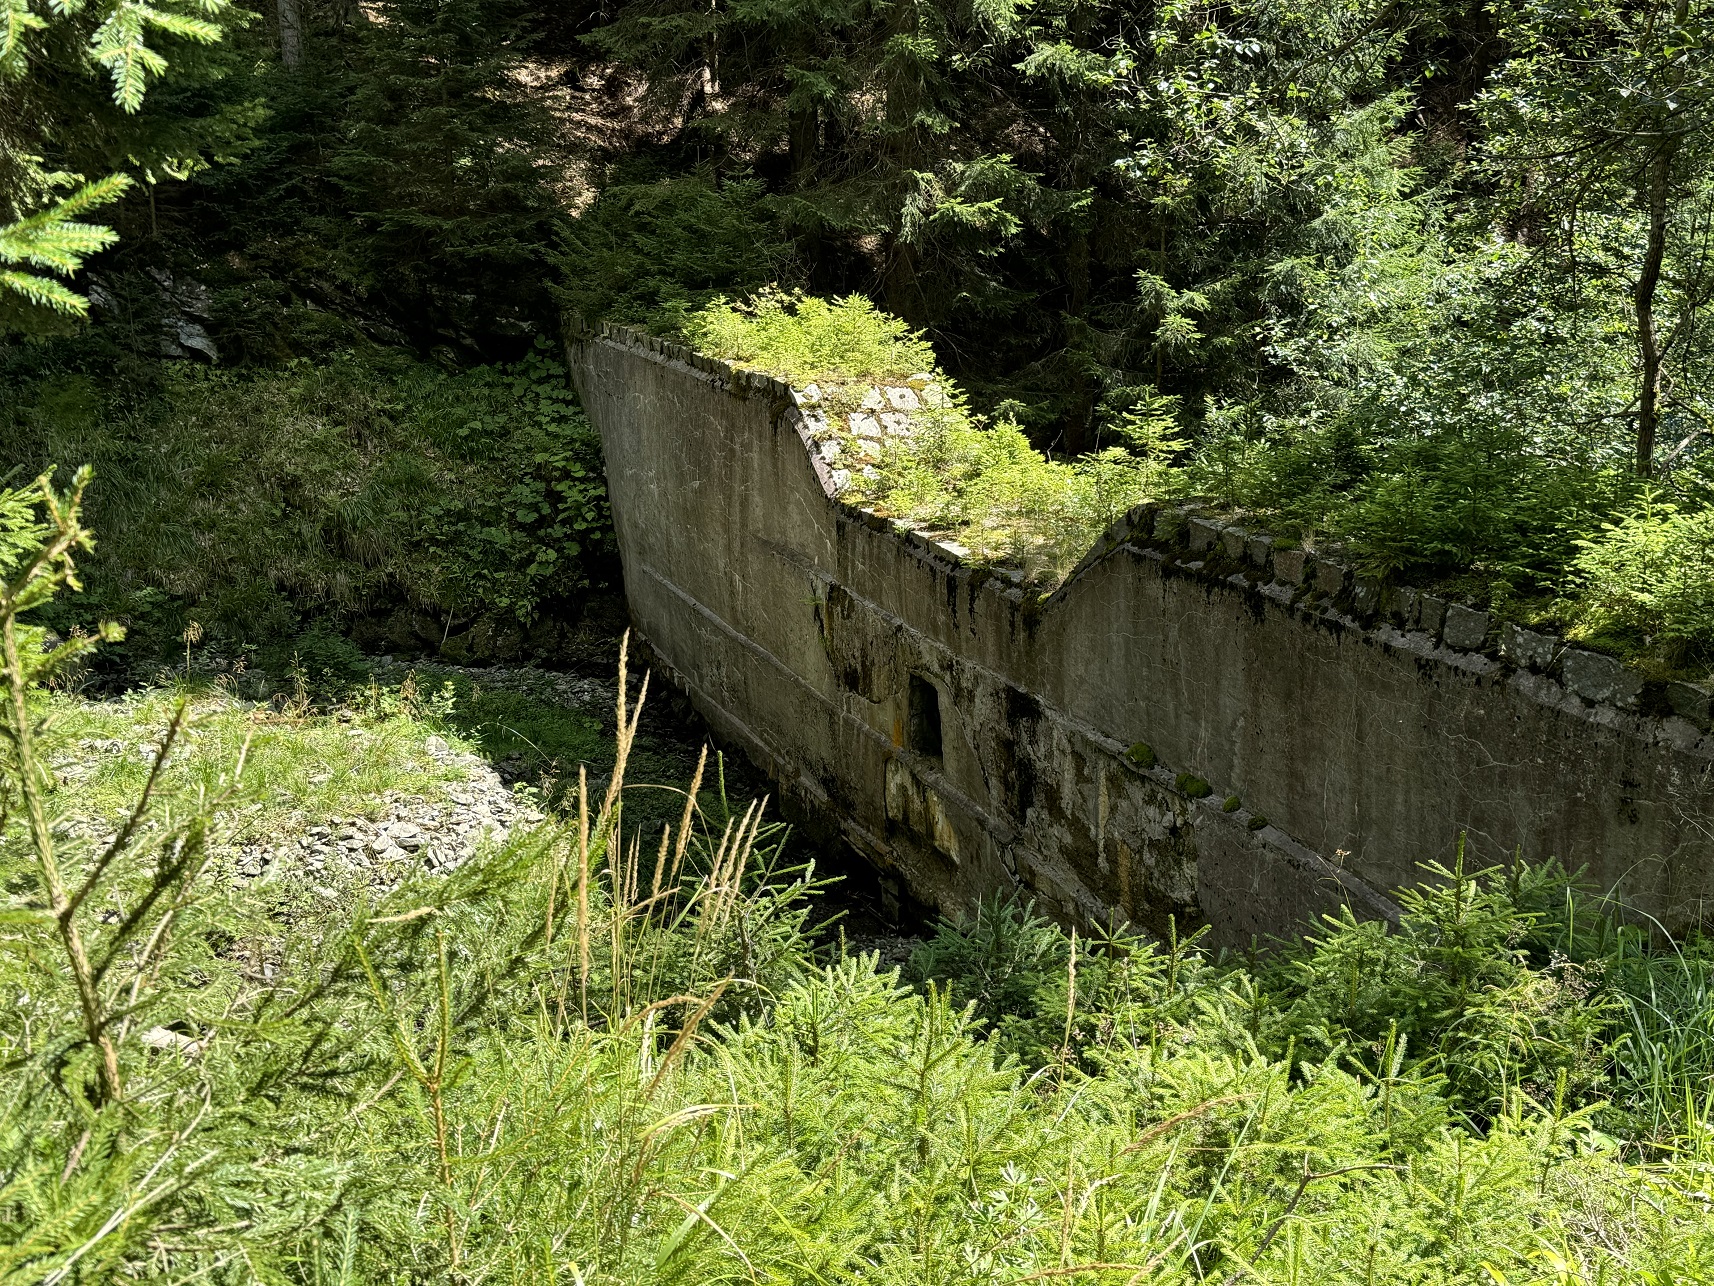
left=0, top=476, right=1714, bottom=1286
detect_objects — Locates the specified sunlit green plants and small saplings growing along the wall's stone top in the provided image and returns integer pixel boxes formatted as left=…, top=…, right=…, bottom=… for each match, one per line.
left=682, top=290, right=1714, bottom=674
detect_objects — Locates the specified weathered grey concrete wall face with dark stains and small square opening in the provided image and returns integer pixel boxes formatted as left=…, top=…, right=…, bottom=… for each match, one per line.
left=569, top=329, right=1714, bottom=945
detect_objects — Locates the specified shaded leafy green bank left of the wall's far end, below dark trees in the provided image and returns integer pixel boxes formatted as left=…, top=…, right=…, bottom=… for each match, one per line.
left=0, top=337, right=612, bottom=662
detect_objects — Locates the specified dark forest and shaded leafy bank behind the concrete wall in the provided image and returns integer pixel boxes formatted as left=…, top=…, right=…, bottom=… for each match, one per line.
left=0, top=0, right=1714, bottom=672
